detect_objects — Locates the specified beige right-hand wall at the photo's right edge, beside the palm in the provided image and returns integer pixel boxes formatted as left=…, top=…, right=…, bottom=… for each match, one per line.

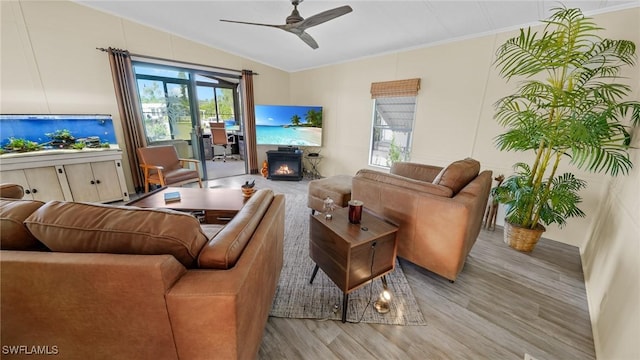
left=581, top=8, right=640, bottom=359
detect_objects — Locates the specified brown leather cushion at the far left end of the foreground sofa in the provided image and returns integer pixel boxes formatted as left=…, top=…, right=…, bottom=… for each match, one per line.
left=0, top=199, right=44, bottom=250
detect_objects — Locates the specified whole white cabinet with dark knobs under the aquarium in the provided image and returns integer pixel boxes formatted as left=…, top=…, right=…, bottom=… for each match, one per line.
left=0, top=149, right=129, bottom=202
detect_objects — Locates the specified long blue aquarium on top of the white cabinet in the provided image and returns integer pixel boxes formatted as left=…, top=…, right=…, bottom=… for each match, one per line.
left=0, top=114, right=117, bottom=150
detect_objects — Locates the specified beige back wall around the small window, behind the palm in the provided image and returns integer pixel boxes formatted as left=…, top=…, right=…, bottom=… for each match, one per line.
left=290, top=10, right=638, bottom=250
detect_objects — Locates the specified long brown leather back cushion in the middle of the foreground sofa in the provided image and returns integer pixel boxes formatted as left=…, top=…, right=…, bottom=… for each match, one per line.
left=25, top=201, right=207, bottom=267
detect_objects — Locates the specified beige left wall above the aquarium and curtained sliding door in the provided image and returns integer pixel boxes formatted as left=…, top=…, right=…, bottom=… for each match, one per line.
left=0, top=1, right=289, bottom=191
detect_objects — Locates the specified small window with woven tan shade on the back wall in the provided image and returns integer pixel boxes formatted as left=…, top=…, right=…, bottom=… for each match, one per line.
left=369, top=79, right=420, bottom=167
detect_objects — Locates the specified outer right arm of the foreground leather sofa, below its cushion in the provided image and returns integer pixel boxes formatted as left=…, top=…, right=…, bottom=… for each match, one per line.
left=167, top=194, right=284, bottom=359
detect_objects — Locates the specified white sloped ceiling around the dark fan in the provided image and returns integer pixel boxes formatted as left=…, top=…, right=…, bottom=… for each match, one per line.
left=76, top=0, right=640, bottom=72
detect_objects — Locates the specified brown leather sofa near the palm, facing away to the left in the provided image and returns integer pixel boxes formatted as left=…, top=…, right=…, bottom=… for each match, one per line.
left=351, top=159, right=492, bottom=281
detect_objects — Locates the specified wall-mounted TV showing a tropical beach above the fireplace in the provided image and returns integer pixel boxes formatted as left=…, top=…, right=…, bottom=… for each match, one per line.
left=255, top=105, right=322, bottom=146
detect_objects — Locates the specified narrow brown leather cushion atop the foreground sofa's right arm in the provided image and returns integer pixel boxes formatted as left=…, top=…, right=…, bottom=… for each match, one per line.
left=198, top=189, right=274, bottom=269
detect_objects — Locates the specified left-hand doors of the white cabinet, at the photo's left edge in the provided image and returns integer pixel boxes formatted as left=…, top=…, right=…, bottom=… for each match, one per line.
left=0, top=166, right=65, bottom=201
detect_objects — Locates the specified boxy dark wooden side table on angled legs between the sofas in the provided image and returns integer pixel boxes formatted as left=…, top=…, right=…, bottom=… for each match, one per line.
left=309, top=207, right=398, bottom=323
